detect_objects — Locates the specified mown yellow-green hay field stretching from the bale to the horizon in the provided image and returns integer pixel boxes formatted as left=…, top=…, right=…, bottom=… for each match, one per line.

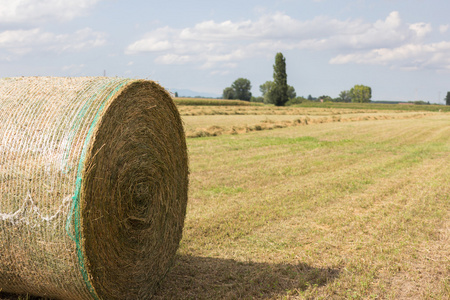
left=0, top=107, right=450, bottom=299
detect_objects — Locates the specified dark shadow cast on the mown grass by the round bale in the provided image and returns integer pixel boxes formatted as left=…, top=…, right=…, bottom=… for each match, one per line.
left=154, top=255, right=340, bottom=300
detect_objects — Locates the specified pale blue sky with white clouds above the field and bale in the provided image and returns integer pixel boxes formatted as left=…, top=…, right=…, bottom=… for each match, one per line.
left=0, top=0, right=450, bottom=104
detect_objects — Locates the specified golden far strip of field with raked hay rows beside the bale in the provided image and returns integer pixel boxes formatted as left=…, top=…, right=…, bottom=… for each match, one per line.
left=179, top=106, right=438, bottom=137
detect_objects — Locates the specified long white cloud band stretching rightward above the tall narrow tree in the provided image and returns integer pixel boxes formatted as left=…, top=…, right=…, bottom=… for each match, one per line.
left=125, top=11, right=443, bottom=73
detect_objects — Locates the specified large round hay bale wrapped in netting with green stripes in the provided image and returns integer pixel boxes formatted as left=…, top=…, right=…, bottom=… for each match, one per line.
left=0, top=77, right=188, bottom=299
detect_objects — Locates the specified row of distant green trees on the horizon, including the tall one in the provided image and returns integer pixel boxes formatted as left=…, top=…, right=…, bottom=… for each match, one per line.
left=222, top=53, right=372, bottom=106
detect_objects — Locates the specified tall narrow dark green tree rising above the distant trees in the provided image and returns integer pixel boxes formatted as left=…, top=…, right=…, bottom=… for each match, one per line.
left=269, top=52, right=289, bottom=106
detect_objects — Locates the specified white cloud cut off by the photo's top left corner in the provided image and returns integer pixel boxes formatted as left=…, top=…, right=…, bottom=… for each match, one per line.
left=0, top=0, right=101, bottom=24
